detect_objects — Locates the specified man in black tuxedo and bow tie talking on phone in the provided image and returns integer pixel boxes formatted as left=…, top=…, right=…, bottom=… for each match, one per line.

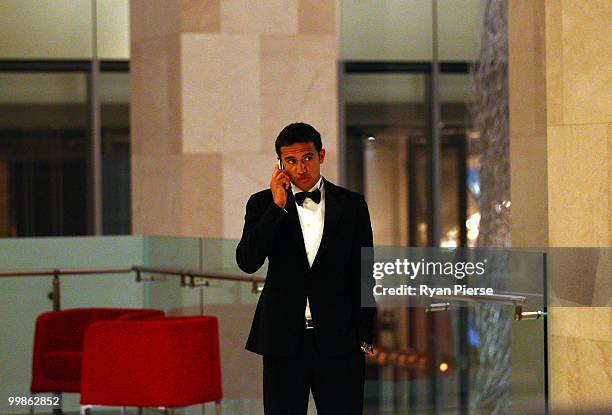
left=236, top=123, right=376, bottom=415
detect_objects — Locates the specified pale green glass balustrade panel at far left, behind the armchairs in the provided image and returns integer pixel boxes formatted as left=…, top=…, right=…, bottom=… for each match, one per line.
left=0, top=236, right=144, bottom=414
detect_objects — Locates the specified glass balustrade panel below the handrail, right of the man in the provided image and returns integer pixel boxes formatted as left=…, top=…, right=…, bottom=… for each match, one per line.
left=365, top=304, right=546, bottom=414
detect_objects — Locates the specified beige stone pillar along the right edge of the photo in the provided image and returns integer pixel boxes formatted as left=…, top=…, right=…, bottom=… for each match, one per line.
left=508, top=0, right=612, bottom=413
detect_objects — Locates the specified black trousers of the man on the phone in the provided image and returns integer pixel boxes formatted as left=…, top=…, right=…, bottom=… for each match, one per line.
left=263, top=330, right=365, bottom=415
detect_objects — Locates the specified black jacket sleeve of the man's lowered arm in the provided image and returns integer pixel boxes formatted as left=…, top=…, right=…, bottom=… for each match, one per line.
left=352, top=195, right=376, bottom=344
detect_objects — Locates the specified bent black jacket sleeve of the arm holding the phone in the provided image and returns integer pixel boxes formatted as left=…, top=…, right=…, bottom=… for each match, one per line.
left=236, top=195, right=287, bottom=274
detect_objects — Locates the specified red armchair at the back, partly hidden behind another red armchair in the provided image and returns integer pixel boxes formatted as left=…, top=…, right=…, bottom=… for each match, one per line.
left=30, top=308, right=164, bottom=393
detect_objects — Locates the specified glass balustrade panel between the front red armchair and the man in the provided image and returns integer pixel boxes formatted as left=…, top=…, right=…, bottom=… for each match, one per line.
left=145, top=237, right=266, bottom=414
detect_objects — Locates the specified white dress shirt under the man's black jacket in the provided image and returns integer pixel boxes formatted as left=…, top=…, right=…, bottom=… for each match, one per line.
left=291, top=176, right=325, bottom=318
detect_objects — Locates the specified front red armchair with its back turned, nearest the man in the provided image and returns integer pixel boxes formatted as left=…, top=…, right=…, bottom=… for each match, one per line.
left=81, top=316, right=223, bottom=412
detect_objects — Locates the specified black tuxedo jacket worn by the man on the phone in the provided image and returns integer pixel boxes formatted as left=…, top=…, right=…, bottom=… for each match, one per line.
left=236, top=178, right=376, bottom=356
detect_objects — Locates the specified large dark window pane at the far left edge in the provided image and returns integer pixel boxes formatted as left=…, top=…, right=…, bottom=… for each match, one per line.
left=0, top=73, right=89, bottom=236
